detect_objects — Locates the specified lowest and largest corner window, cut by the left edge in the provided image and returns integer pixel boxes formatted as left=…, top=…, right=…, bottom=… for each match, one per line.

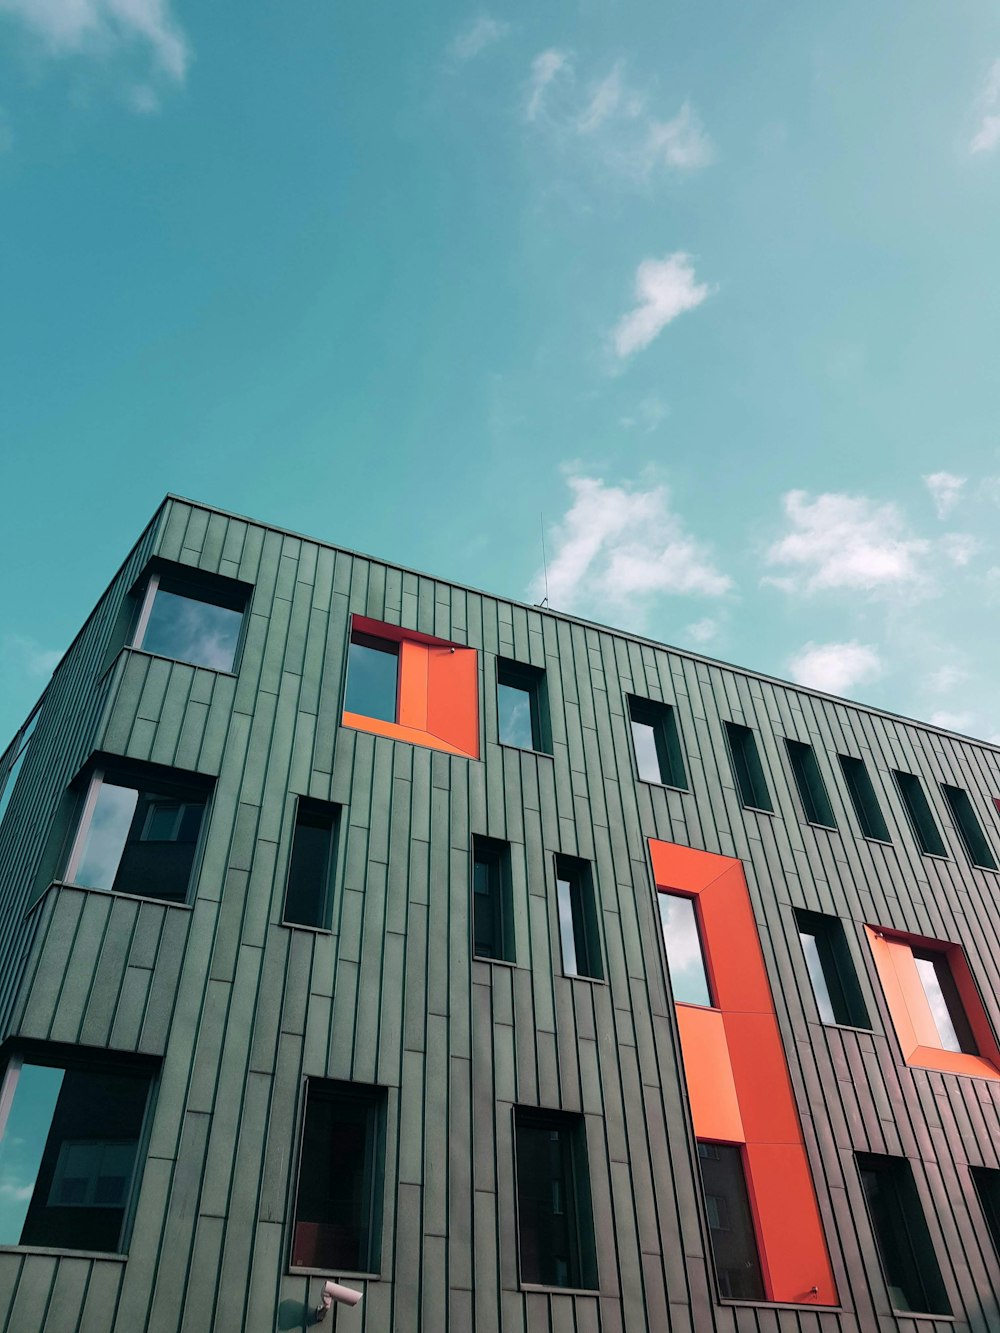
left=0, top=1056, right=151, bottom=1253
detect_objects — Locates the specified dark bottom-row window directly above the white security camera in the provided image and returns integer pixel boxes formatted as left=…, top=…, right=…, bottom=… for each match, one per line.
left=292, top=1078, right=385, bottom=1273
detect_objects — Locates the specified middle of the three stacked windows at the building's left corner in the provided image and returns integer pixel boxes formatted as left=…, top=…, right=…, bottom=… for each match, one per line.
left=64, top=769, right=208, bottom=902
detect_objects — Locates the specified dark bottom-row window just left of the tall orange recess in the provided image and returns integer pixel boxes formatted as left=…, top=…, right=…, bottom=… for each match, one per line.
left=515, top=1106, right=597, bottom=1289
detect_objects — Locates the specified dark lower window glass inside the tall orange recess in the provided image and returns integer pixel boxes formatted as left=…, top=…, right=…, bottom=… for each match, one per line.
left=697, top=1144, right=764, bottom=1301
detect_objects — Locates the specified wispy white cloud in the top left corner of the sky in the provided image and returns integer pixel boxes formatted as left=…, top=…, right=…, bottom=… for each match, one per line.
left=0, top=0, right=191, bottom=83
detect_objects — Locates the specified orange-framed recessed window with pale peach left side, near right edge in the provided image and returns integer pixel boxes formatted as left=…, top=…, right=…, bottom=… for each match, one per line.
left=864, top=925, right=1000, bottom=1080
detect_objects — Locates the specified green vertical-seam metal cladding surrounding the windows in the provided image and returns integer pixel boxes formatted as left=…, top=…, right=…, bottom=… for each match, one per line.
left=0, top=499, right=1000, bottom=1333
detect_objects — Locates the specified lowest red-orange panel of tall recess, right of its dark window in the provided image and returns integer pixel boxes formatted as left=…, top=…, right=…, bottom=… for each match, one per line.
left=745, top=1142, right=837, bottom=1305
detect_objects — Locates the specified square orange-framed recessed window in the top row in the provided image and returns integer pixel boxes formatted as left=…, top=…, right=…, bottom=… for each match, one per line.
left=341, top=616, right=479, bottom=758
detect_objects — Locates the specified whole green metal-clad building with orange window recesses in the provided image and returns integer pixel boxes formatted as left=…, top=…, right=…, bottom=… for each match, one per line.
left=0, top=497, right=1000, bottom=1333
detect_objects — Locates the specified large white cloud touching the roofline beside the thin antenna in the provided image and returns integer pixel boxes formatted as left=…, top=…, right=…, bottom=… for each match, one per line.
left=532, top=476, right=732, bottom=612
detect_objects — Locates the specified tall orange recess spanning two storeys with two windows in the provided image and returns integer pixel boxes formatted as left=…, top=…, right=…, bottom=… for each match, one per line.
left=649, top=838, right=837, bottom=1305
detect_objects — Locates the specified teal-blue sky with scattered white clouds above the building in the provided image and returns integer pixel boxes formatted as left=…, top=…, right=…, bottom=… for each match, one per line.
left=0, top=0, right=1000, bottom=740
